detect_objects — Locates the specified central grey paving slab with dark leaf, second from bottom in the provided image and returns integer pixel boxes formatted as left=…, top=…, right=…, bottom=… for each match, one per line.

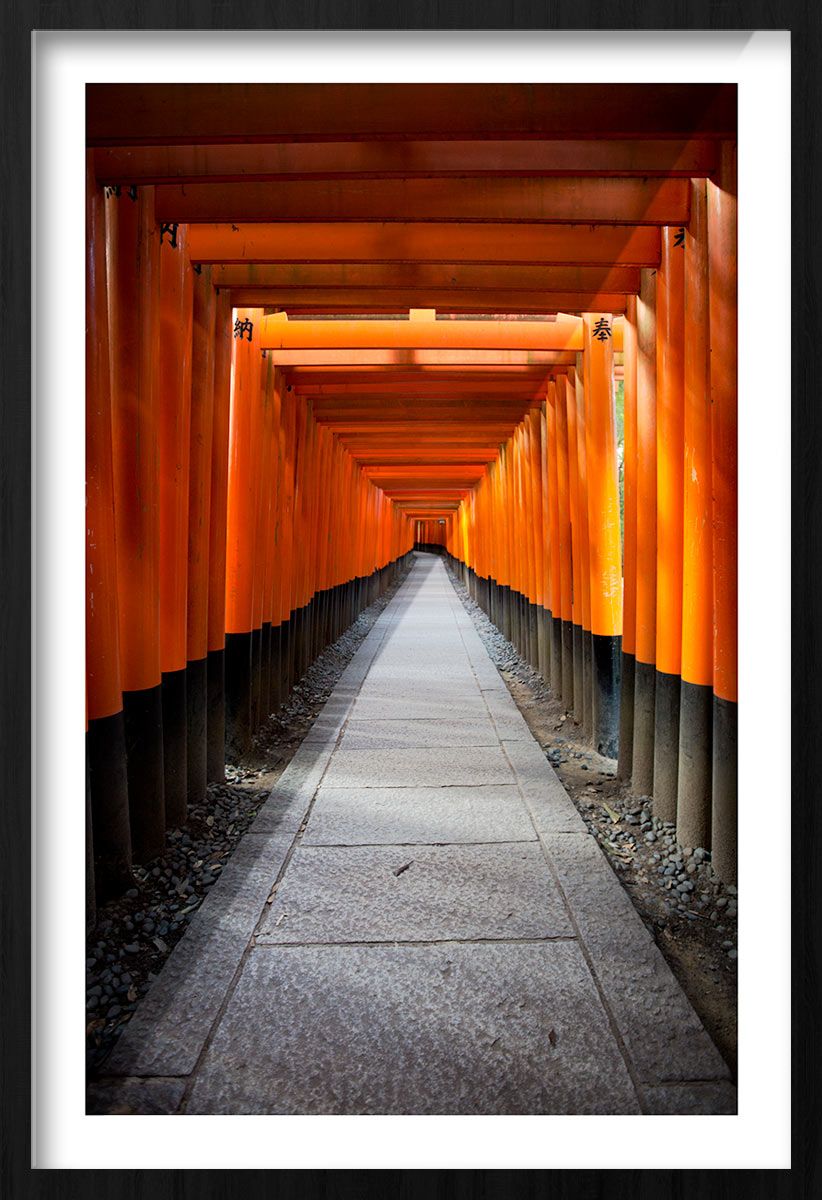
left=257, top=842, right=574, bottom=943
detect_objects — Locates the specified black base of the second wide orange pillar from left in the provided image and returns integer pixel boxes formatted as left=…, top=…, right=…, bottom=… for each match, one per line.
left=122, top=684, right=166, bottom=863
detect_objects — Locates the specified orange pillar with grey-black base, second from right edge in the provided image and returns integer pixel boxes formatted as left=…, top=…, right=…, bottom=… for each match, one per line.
left=677, top=179, right=713, bottom=847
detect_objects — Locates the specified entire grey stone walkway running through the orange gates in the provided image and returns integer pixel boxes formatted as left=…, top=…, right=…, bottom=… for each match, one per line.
left=89, top=556, right=736, bottom=1114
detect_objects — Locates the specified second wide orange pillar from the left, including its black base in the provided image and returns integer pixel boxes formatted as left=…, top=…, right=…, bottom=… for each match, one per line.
left=107, top=186, right=166, bottom=863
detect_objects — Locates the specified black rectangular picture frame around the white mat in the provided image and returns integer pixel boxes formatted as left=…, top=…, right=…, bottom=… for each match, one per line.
left=0, top=0, right=822, bottom=1200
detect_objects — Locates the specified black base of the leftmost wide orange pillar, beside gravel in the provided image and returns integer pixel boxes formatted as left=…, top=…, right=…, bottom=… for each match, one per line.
left=85, top=713, right=132, bottom=902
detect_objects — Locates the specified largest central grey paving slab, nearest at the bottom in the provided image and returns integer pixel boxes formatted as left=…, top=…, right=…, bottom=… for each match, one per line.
left=186, top=942, right=640, bottom=1115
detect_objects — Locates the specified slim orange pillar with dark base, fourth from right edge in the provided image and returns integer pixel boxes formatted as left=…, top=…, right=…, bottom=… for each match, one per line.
left=631, top=269, right=656, bottom=796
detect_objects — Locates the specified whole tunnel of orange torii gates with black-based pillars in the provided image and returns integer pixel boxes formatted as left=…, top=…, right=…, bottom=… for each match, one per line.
left=86, top=84, right=737, bottom=904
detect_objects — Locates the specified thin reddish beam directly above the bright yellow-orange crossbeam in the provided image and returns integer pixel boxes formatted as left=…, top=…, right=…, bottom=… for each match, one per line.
left=232, top=287, right=628, bottom=314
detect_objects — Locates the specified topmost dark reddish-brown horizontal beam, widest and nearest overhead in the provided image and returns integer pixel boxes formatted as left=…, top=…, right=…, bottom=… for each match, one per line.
left=86, top=83, right=737, bottom=145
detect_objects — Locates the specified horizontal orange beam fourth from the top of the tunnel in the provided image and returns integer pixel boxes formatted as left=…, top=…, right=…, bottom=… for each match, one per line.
left=188, top=220, right=660, bottom=266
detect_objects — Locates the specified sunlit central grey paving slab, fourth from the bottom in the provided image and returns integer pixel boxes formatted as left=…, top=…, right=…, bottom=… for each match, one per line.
left=324, top=744, right=514, bottom=787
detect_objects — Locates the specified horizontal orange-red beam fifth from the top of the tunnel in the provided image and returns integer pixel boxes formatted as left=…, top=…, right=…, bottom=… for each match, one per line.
left=211, top=263, right=640, bottom=295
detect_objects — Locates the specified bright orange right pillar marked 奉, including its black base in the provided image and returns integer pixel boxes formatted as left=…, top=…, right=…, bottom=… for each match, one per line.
left=583, top=313, right=622, bottom=758
